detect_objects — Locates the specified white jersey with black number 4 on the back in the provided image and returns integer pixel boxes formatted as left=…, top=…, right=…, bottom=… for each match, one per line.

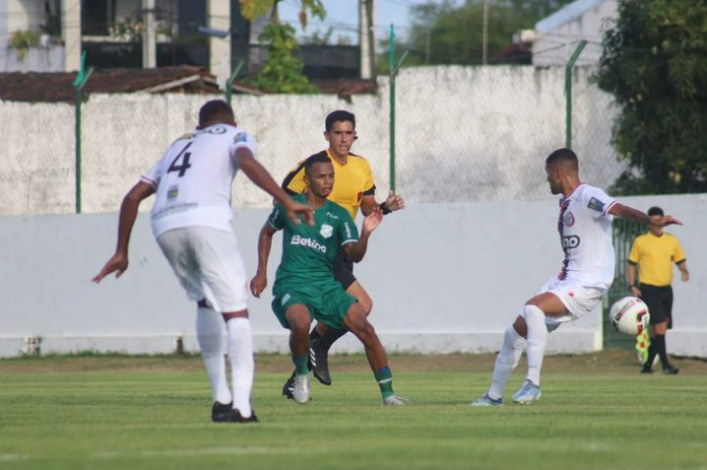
left=141, top=124, right=255, bottom=236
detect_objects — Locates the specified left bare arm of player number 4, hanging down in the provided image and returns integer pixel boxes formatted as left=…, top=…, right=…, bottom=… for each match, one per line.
left=93, top=181, right=155, bottom=284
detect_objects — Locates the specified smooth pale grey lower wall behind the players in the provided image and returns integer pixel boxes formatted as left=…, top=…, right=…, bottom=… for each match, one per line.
left=0, top=193, right=707, bottom=357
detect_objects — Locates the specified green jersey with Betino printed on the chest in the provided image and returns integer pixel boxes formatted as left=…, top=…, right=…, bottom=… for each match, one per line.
left=268, top=194, right=358, bottom=284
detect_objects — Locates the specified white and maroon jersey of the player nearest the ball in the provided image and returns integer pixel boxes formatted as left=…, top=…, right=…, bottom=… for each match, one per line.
left=557, top=184, right=616, bottom=289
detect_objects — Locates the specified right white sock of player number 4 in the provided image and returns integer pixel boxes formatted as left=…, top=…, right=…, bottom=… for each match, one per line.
left=226, top=318, right=255, bottom=418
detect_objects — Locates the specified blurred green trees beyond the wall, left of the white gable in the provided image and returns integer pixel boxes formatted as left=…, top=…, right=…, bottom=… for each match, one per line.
left=402, top=0, right=572, bottom=65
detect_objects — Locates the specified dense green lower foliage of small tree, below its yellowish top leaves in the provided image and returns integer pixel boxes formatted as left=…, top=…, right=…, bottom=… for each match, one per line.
left=247, top=24, right=317, bottom=93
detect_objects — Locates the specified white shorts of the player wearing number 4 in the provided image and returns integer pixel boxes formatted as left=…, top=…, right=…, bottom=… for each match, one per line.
left=157, top=226, right=248, bottom=313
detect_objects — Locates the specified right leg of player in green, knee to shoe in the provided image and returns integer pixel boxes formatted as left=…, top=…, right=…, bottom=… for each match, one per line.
left=344, top=303, right=407, bottom=406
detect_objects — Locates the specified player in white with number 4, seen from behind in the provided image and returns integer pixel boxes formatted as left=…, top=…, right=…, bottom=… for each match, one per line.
left=93, top=100, right=314, bottom=423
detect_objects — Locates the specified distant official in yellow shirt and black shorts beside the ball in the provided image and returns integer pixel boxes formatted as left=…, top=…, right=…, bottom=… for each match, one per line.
left=628, top=207, right=690, bottom=375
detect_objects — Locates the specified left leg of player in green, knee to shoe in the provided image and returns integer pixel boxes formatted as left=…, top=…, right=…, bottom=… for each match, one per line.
left=283, top=304, right=311, bottom=405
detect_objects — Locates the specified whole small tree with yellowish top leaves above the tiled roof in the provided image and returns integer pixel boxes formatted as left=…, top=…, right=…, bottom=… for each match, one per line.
left=240, top=0, right=326, bottom=93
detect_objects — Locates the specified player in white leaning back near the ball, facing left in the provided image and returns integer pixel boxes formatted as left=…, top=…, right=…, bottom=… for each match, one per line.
left=471, top=149, right=680, bottom=406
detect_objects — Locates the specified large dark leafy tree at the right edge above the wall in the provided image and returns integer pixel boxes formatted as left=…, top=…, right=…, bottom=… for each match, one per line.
left=597, top=0, right=707, bottom=194
